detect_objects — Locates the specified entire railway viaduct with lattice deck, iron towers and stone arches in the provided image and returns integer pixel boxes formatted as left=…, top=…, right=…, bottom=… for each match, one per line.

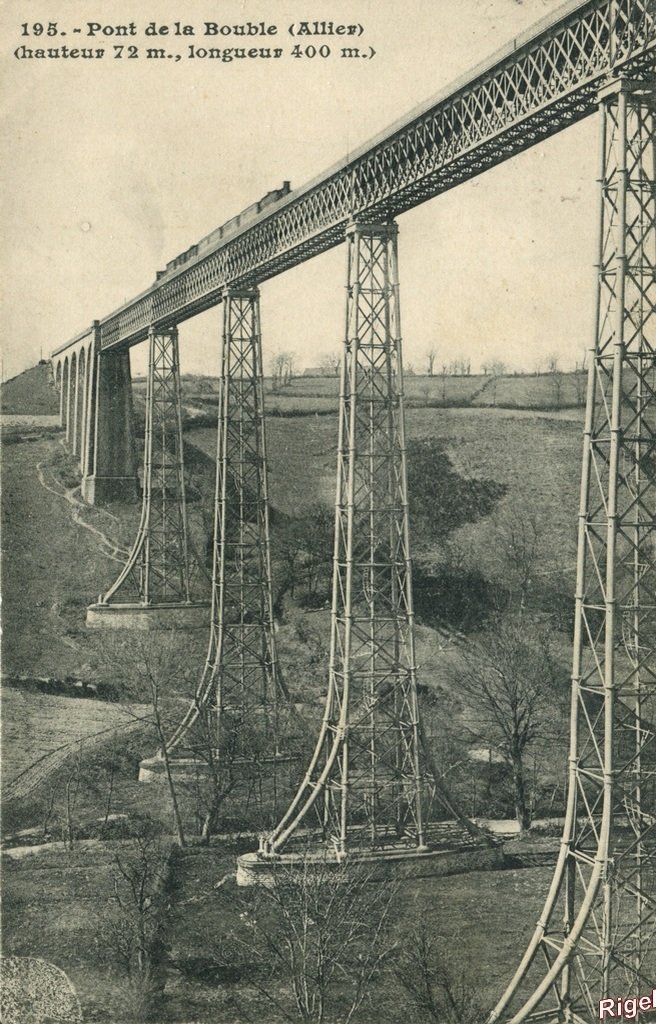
left=52, top=0, right=656, bottom=1024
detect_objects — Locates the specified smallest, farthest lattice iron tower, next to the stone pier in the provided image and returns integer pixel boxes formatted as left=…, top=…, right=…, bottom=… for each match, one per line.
left=100, top=329, right=191, bottom=606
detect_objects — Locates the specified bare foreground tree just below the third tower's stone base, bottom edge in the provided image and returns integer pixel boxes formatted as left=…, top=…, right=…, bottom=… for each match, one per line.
left=236, top=858, right=396, bottom=1024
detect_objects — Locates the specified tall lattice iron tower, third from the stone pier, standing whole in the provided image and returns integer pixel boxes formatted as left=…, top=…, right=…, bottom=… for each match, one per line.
left=256, top=224, right=431, bottom=856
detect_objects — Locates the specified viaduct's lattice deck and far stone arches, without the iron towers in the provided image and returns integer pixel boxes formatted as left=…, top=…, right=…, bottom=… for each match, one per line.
left=51, top=0, right=654, bottom=504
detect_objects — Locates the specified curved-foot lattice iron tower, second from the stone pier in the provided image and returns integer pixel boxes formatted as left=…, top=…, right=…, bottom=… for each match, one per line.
left=170, top=289, right=287, bottom=765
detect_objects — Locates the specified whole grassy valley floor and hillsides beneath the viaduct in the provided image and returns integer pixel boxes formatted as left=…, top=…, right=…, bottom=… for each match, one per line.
left=3, top=362, right=580, bottom=1024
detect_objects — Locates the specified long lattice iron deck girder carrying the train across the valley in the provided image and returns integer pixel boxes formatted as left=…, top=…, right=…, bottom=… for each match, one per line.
left=52, top=0, right=656, bottom=360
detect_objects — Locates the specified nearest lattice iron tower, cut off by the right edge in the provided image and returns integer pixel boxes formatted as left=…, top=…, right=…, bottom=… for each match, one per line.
left=490, top=80, right=656, bottom=1024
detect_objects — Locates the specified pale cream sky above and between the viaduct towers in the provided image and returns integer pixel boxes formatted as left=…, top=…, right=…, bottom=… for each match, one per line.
left=0, top=0, right=598, bottom=379
